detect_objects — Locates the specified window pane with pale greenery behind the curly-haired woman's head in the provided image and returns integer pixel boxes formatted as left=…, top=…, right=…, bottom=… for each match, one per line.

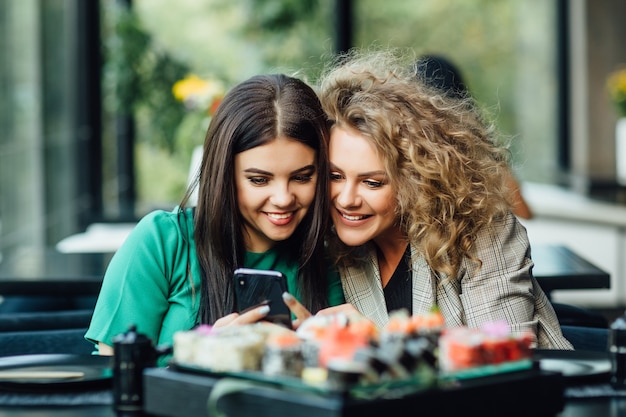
left=354, top=0, right=558, bottom=182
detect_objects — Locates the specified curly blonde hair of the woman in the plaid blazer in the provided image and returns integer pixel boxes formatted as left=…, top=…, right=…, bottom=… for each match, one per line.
left=319, top=50, right=510, bottom=278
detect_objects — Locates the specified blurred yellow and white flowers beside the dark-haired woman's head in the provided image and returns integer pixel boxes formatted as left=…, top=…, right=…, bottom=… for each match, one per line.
left=172, top=74, right=224, bottom=115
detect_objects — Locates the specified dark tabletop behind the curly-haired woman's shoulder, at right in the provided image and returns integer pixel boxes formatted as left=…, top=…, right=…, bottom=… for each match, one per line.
left=531, top=244, right=611, bottom=294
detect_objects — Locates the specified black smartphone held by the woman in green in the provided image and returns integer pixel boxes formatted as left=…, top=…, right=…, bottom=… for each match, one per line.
left=235, top=268, right=292, bottom=329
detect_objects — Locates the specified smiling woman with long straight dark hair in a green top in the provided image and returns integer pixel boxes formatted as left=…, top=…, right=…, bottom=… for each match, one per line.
left=85, top=75, right=344, bottom=360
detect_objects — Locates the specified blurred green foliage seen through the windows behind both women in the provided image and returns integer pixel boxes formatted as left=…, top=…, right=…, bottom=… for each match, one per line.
left=102, top=0, right=556, bottom=212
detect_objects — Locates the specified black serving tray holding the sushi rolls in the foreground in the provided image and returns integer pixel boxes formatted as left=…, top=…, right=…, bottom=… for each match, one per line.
left=144, top=368, right=565, bottom=417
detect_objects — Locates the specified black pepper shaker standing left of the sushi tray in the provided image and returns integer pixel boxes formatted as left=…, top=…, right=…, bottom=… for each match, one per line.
left=112, top=326, right=157, bottom=417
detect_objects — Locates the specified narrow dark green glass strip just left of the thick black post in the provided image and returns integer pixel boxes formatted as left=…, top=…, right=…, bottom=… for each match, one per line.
left=41, top=0, right=79, bottom=245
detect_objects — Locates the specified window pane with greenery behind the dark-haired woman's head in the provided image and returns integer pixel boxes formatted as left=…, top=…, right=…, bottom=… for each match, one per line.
left=104, top=0, right=332, bottom=216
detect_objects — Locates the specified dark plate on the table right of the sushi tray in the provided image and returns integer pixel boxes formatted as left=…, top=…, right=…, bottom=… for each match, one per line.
left=535, top=349, right=611, bottom=382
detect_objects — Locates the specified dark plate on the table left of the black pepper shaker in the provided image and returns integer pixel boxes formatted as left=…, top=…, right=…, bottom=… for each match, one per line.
left=0, top=354, right=113, bottom=391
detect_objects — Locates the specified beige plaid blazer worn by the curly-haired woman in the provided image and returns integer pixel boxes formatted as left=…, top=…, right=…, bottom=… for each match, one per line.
left=339, top=213, right=573, bottom=349
